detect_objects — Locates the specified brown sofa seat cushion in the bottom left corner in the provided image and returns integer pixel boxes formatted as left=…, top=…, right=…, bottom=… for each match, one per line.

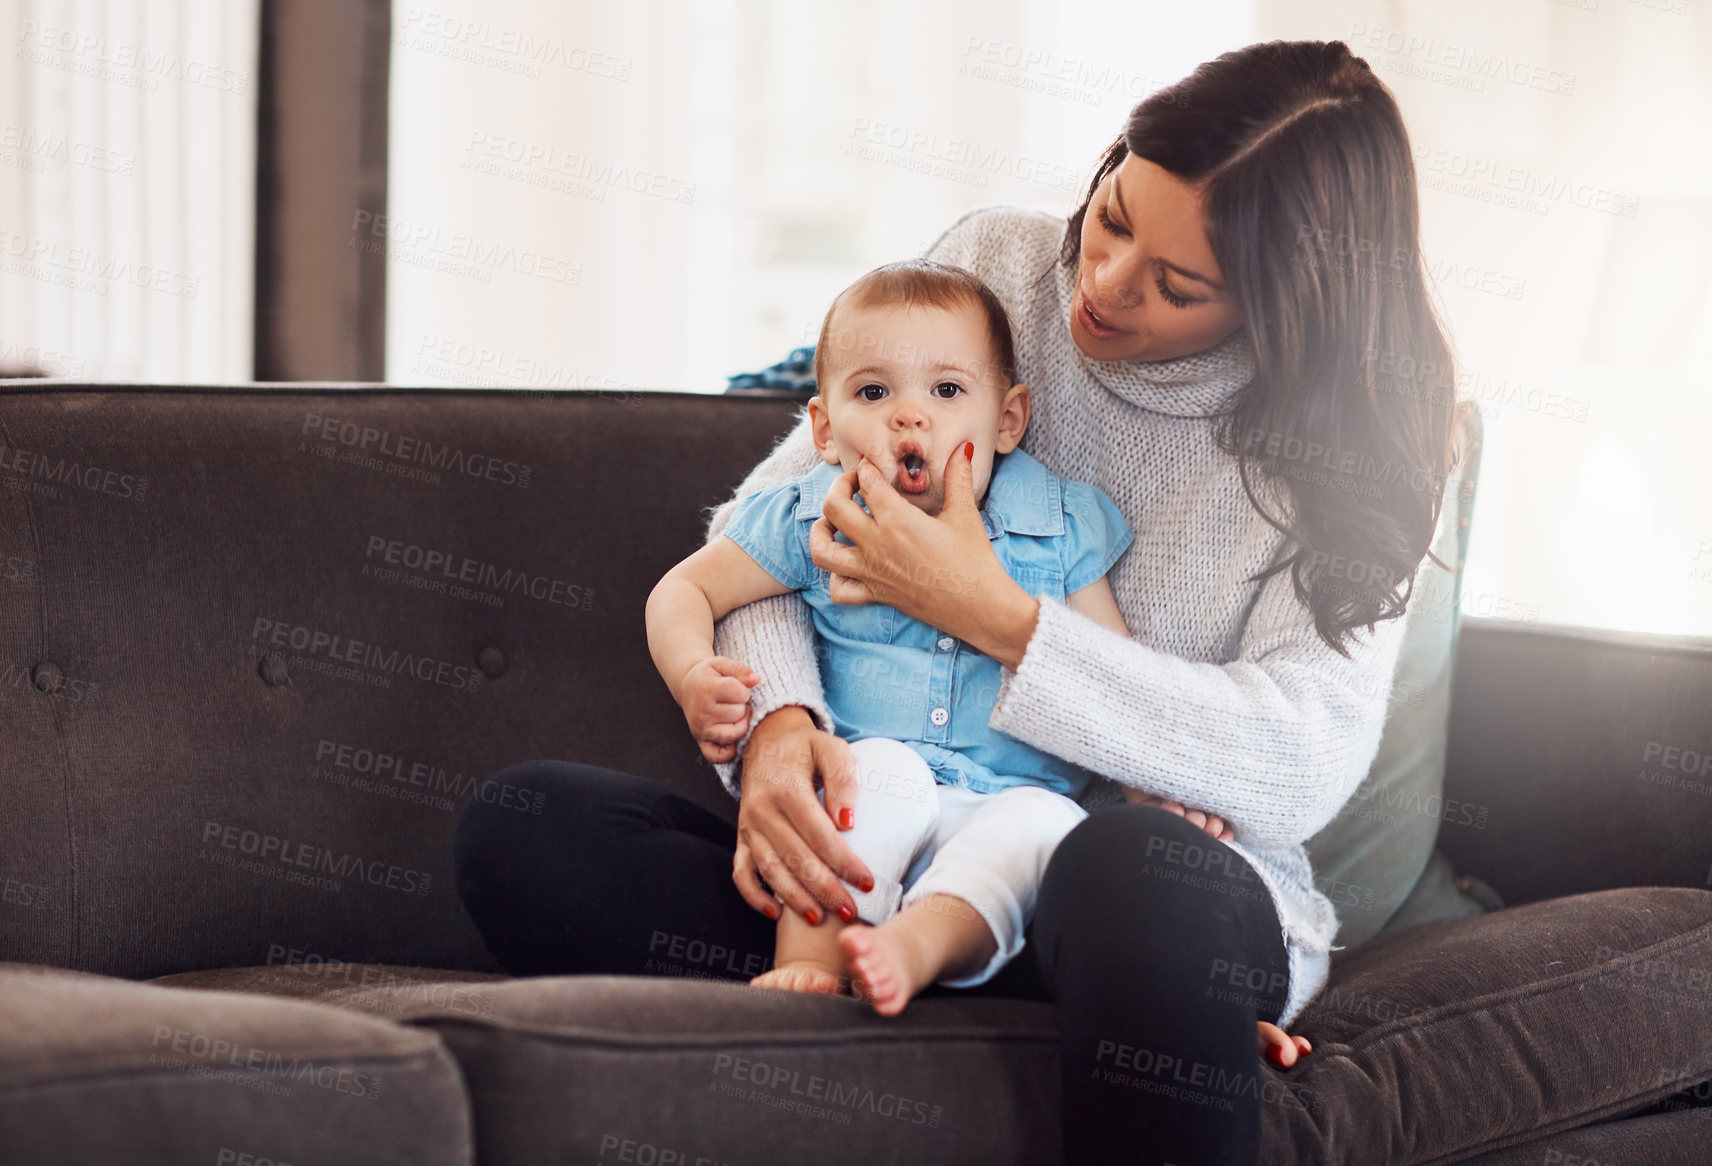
left=0, top=964, right=473, bottom=1166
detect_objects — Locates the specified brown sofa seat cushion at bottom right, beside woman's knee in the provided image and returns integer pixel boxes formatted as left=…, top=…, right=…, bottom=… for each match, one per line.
left=1262, top=887, right=1712, bottom=1166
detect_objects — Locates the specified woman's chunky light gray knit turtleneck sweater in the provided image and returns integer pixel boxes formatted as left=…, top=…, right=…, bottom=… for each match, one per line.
left=709, top=207, right=1406, bottom=1026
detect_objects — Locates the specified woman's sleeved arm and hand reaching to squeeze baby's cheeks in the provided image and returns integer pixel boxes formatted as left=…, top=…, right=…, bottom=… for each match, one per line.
left=810, top=455, right=1402, bottom=844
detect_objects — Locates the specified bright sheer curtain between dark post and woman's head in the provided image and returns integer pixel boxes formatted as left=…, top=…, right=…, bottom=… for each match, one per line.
left=387, top=0, right=1248, bottom=390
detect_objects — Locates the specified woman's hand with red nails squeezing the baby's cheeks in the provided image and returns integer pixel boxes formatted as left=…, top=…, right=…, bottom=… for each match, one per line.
left=808, top=442, right=1039, bottom=668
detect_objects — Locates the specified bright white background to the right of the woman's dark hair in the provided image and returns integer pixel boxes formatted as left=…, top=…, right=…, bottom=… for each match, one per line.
left=1258, top=0, right=1712, bottom=635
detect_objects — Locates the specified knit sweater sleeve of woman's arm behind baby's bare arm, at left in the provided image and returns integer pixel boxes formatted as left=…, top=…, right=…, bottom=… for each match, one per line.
left=707, top=413, right=834, bottom=798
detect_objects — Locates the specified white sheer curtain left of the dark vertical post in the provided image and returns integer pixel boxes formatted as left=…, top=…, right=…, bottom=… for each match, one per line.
left=0, top=0, right=259, bottom=382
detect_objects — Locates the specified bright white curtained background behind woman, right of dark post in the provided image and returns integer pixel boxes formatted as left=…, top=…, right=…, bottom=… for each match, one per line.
left=387, top=0, right=1712, bottom=635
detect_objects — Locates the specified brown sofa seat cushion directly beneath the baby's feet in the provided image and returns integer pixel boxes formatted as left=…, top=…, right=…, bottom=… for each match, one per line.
left=374, top=976, right=1060, bottom=1166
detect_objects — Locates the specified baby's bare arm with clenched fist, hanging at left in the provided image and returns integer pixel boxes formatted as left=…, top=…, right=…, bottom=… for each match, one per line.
left=647, top=538, right=791, bottom=762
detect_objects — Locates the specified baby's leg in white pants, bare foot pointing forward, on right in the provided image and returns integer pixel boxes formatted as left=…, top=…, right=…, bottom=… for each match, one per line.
left=839, top=786, right=1087, bottom=1015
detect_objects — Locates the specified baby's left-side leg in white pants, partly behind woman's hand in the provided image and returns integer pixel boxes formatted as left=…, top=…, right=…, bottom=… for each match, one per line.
left=750, top=736, right=940, bottom=993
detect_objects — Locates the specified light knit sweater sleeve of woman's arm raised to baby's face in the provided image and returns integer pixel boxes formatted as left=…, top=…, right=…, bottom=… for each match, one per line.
left=990, top=572, right=1407, bottom=846
